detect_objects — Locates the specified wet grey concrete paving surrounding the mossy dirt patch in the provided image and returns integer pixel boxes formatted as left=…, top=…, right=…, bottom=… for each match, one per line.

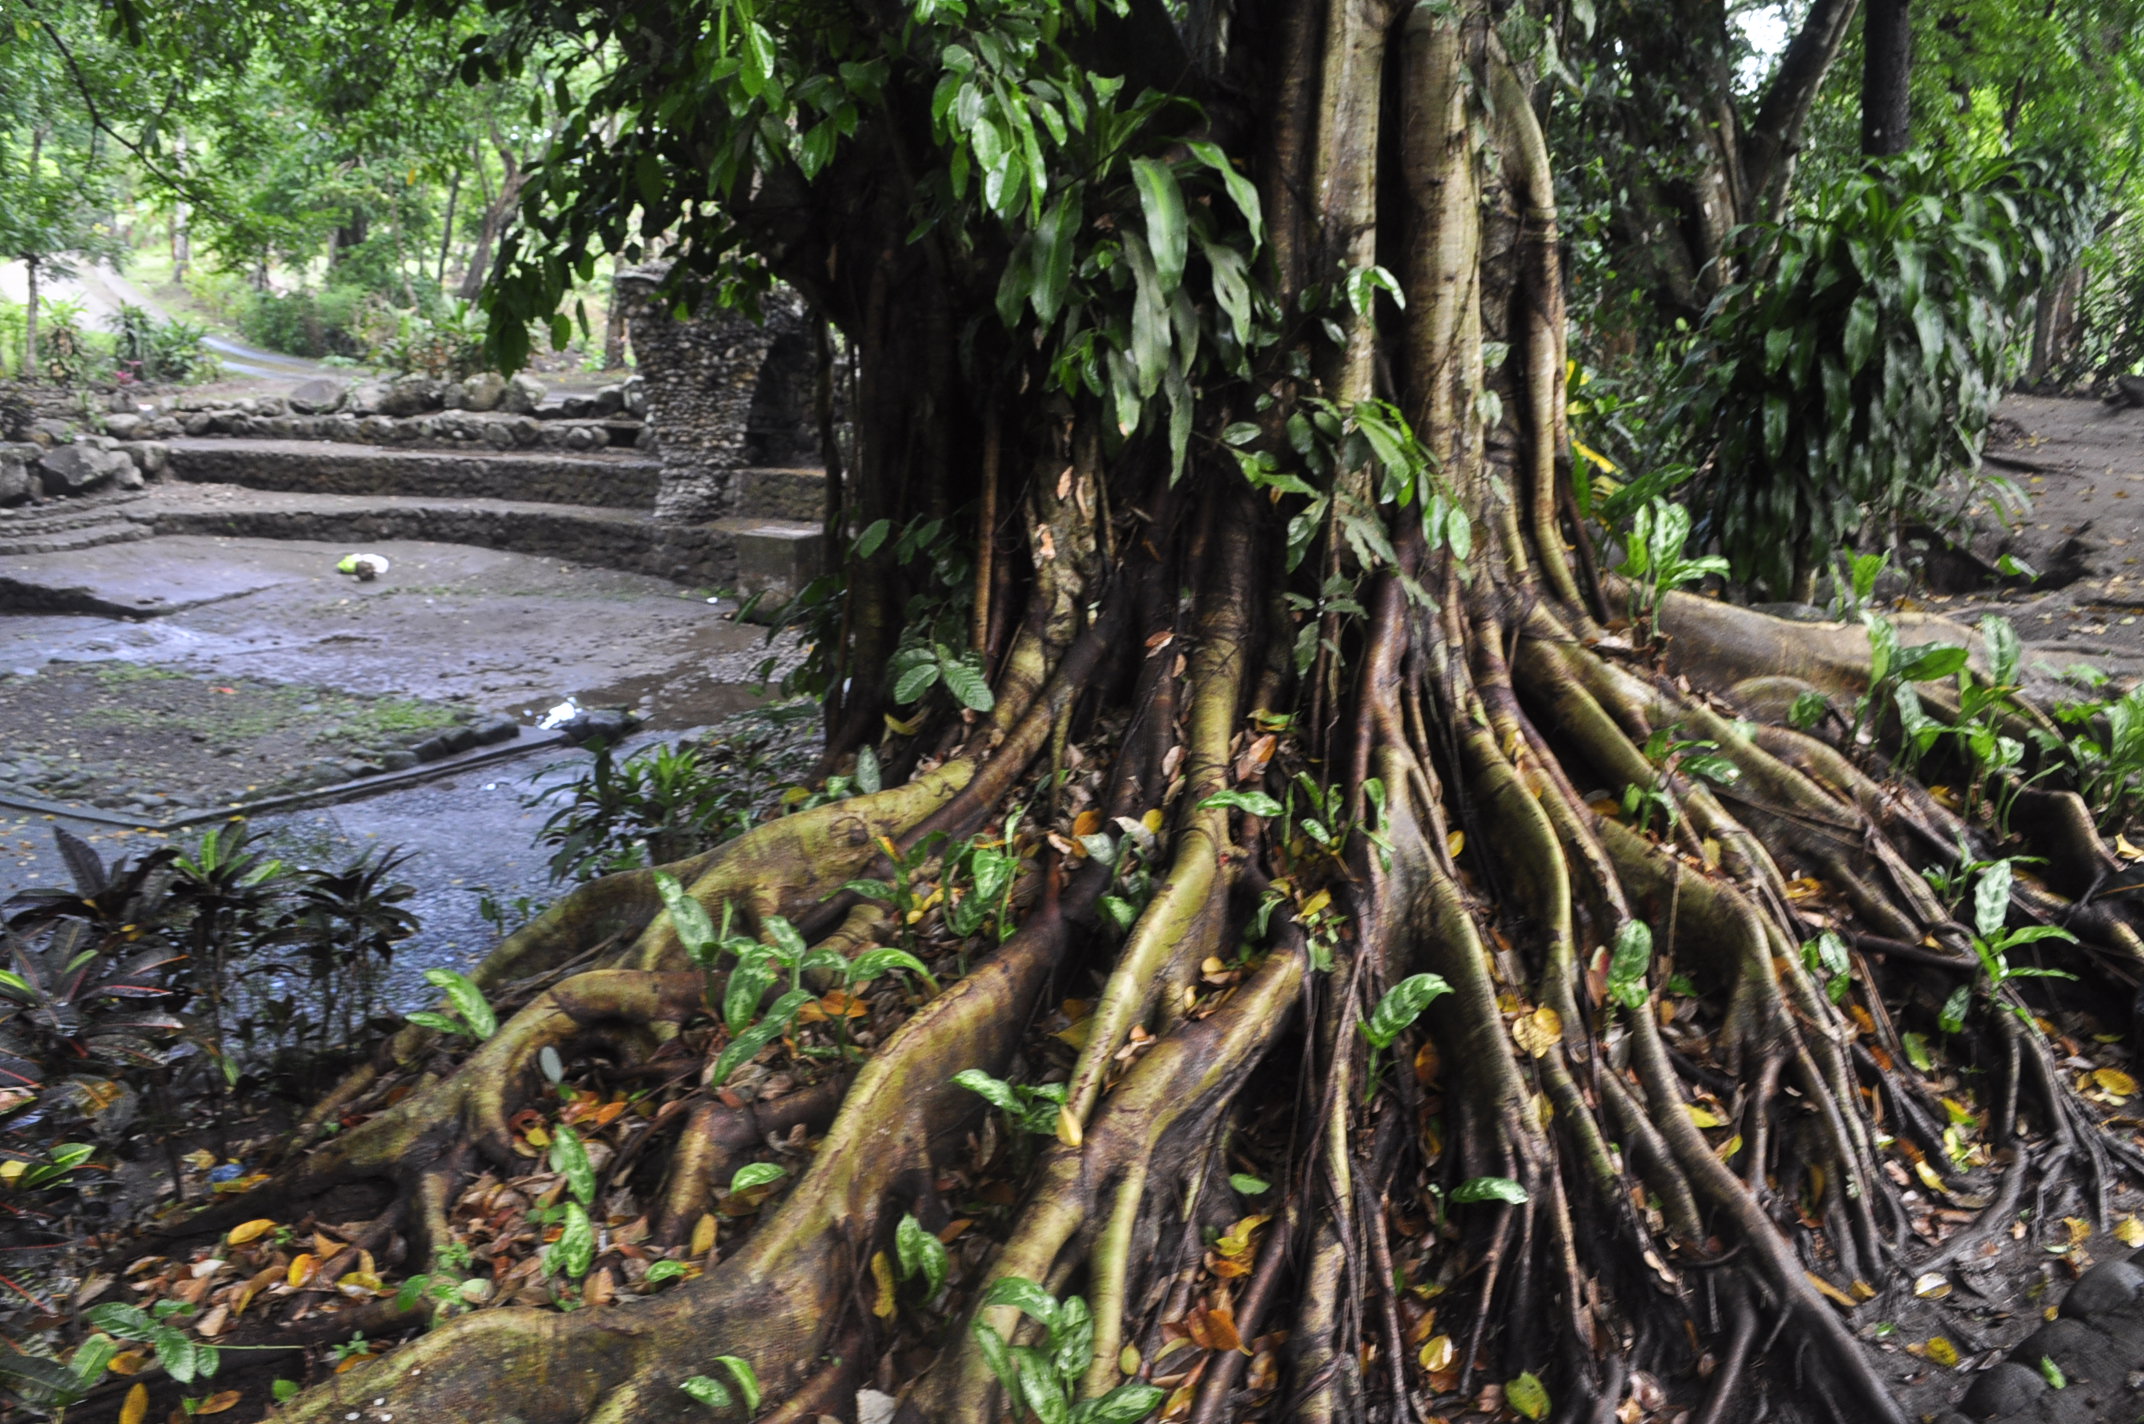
left=0, top=536, right=806, bottom=1008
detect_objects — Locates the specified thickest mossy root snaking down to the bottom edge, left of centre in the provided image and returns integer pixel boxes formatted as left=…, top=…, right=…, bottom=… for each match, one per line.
left=281, top=901, right=1066, bottom=1424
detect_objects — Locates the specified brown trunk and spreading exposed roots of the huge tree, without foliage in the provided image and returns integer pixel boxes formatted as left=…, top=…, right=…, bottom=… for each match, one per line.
left=100, top=4, right=2144, bottom=1424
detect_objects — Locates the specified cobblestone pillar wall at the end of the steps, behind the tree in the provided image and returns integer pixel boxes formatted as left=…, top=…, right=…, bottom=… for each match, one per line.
left=617, top=266, right=819, bottom=521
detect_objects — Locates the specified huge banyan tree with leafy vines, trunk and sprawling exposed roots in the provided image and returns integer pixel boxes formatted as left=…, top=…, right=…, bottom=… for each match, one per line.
left=155, top=0, right=2144, bottom=1424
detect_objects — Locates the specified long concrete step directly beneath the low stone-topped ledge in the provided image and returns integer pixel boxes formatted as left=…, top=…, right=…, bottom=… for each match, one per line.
left=165, top=446, right=660, bottom=510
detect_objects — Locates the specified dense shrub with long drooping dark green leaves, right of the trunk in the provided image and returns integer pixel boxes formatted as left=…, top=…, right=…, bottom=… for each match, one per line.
left=1655, top=154, right=2093, bottom=598
